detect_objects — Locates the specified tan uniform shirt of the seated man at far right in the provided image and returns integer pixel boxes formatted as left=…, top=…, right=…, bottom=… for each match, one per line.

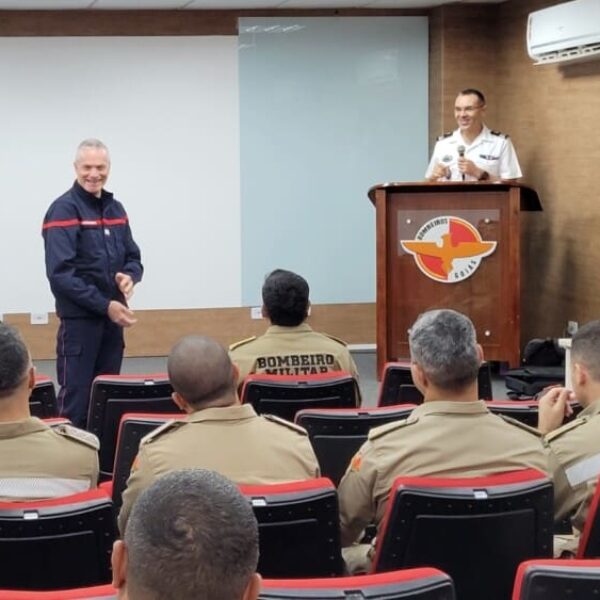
left=545, top=400, right=600, bottom=531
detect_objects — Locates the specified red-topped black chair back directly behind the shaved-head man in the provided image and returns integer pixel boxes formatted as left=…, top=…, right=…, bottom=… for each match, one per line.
left=240, top=477, right=343, bottom=578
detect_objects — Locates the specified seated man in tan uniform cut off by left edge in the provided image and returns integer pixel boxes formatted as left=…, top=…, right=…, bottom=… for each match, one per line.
left=0, top=323, right=99, bottom=500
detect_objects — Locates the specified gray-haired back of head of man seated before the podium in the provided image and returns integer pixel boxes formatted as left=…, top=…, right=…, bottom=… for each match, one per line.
left=408, top=309, right=480, bottom=391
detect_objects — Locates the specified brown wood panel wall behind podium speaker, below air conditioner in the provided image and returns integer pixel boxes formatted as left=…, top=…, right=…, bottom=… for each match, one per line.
left=430, top=0, right=600, bottom=341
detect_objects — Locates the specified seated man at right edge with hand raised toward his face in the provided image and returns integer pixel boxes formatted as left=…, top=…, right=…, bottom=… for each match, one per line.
left=538, top=321, right=600, bottom=555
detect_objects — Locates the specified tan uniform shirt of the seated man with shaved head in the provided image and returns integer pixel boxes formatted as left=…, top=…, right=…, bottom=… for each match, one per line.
left=119, top=404, right=320, bottom=532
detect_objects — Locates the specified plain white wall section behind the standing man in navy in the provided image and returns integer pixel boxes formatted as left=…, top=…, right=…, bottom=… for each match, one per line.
left=0, top=36, right=241, bottom=313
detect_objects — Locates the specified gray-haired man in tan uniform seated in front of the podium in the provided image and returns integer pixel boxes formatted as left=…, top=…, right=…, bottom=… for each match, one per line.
left=338, top=310, right=548, bottom=570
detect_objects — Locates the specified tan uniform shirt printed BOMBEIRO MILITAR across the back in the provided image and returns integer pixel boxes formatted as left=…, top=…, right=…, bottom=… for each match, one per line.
left=229, top=323, right=358, bottom=384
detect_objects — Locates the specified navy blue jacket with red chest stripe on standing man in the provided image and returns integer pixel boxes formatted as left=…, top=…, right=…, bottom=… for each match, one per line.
left=42, top=182, right=143, bottom=318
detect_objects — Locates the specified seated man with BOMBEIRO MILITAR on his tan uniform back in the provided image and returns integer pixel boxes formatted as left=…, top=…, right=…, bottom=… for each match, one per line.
left=229, top=269, right=358, bottom=384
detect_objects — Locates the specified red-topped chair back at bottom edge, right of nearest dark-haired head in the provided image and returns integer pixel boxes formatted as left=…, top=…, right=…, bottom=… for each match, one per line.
left=258, top=568, right=455, bottom=600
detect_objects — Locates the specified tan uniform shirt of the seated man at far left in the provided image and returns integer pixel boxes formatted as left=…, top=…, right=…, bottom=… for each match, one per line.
left=0, top=417, right=100, bottom=500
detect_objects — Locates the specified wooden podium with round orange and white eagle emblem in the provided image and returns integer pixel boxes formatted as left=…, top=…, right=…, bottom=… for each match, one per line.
left=369, top=182, right=542, bottom=373
